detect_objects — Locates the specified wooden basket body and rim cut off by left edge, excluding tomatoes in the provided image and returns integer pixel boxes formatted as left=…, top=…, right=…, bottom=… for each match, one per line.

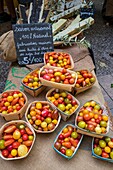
left=0, top=90, right=28, bottom=121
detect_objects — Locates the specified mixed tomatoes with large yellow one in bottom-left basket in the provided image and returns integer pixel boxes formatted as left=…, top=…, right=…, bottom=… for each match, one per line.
left=0, top=121, right=35, bottom=160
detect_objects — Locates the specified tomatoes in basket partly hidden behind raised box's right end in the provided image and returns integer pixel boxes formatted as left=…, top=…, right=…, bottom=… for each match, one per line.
left=75, top=70, right=96, bottom=88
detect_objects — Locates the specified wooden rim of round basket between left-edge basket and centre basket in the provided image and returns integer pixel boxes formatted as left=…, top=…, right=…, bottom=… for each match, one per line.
left=25, top=101, right=61, bottom=133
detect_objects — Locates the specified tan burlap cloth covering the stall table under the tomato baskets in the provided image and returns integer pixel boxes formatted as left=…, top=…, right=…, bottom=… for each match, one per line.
left=0, top=46, right=112, bottom=170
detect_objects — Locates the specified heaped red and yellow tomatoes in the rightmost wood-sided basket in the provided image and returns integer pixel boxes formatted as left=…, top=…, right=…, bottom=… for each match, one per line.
left=75, top=100, right=109, bottom=134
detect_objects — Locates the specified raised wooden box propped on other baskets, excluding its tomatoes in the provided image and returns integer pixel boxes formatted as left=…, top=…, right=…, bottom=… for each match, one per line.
left=39, top=65, right=77, bottom=92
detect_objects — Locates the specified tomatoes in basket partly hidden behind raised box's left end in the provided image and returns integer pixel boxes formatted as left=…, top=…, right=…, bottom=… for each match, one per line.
left=22, top=69, right=41, bottom=89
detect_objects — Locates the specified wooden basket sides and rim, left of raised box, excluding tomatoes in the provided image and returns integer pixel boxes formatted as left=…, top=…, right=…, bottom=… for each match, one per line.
left=21, top=68, right=46, bottom=97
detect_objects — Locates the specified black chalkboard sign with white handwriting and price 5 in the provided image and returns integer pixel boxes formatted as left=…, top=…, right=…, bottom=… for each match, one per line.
left=13, top=23, right=54, bottom=65
